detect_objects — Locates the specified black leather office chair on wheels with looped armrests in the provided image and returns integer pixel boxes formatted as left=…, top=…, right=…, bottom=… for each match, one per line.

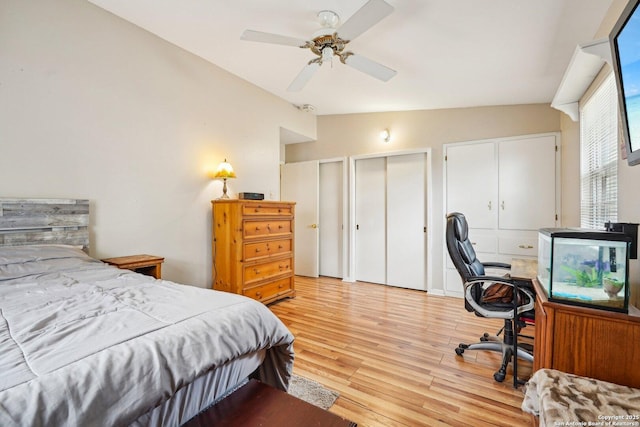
left=446, top=212, right=535, bottom=387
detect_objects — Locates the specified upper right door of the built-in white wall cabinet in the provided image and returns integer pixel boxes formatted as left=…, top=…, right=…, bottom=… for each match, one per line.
left=498, top=135, right=556, bottom=230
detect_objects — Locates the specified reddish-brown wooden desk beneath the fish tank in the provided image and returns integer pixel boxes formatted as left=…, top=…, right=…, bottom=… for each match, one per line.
left=533, top=279, right=640, bottom=388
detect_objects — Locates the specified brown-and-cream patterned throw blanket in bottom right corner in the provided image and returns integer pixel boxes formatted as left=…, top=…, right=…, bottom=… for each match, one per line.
left=522, top=369, right=640, bottom=427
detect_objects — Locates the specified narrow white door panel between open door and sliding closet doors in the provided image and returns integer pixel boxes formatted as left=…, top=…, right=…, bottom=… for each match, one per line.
left=318, top=162, right=343, bottom=278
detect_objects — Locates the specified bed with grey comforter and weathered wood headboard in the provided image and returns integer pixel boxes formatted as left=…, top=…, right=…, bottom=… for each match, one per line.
left=0, top=199, right=294, bottom=426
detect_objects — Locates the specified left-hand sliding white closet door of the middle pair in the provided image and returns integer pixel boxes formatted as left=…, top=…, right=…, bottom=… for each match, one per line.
left=355, top=157, right=387, bottom=284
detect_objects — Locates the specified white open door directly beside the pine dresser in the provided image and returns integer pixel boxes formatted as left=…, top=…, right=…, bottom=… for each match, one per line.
left=280, top=160, right=319, bottom=277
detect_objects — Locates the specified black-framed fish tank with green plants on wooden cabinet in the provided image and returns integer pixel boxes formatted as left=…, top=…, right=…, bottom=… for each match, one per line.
left=538, top=228, right=631, bottom=313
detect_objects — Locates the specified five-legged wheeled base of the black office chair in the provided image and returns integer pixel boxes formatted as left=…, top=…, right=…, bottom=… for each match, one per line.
left=455, top=320, right=533, bottom=387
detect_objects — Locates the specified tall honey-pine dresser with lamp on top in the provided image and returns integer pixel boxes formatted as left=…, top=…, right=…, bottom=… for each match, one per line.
left=211, top=199, right=295, bottom=304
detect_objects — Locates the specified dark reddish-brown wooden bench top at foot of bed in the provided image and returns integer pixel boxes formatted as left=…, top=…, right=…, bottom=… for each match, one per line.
left=184, top=380, right=357, bottom=427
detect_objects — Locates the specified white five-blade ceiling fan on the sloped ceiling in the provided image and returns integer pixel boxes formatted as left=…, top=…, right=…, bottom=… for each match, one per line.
left=240, top=0, right=396, bottom=92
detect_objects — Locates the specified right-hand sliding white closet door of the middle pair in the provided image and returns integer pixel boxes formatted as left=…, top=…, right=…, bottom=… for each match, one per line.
left=387, top=153, right=427, bottom=290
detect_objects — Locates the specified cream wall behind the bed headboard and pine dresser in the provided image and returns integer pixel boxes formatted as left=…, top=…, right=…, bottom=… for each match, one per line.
left=0, top=0, right=316, bottom=287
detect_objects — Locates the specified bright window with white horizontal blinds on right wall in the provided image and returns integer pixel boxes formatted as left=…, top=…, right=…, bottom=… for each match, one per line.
left=580, top=74, right=618, bottom=229
